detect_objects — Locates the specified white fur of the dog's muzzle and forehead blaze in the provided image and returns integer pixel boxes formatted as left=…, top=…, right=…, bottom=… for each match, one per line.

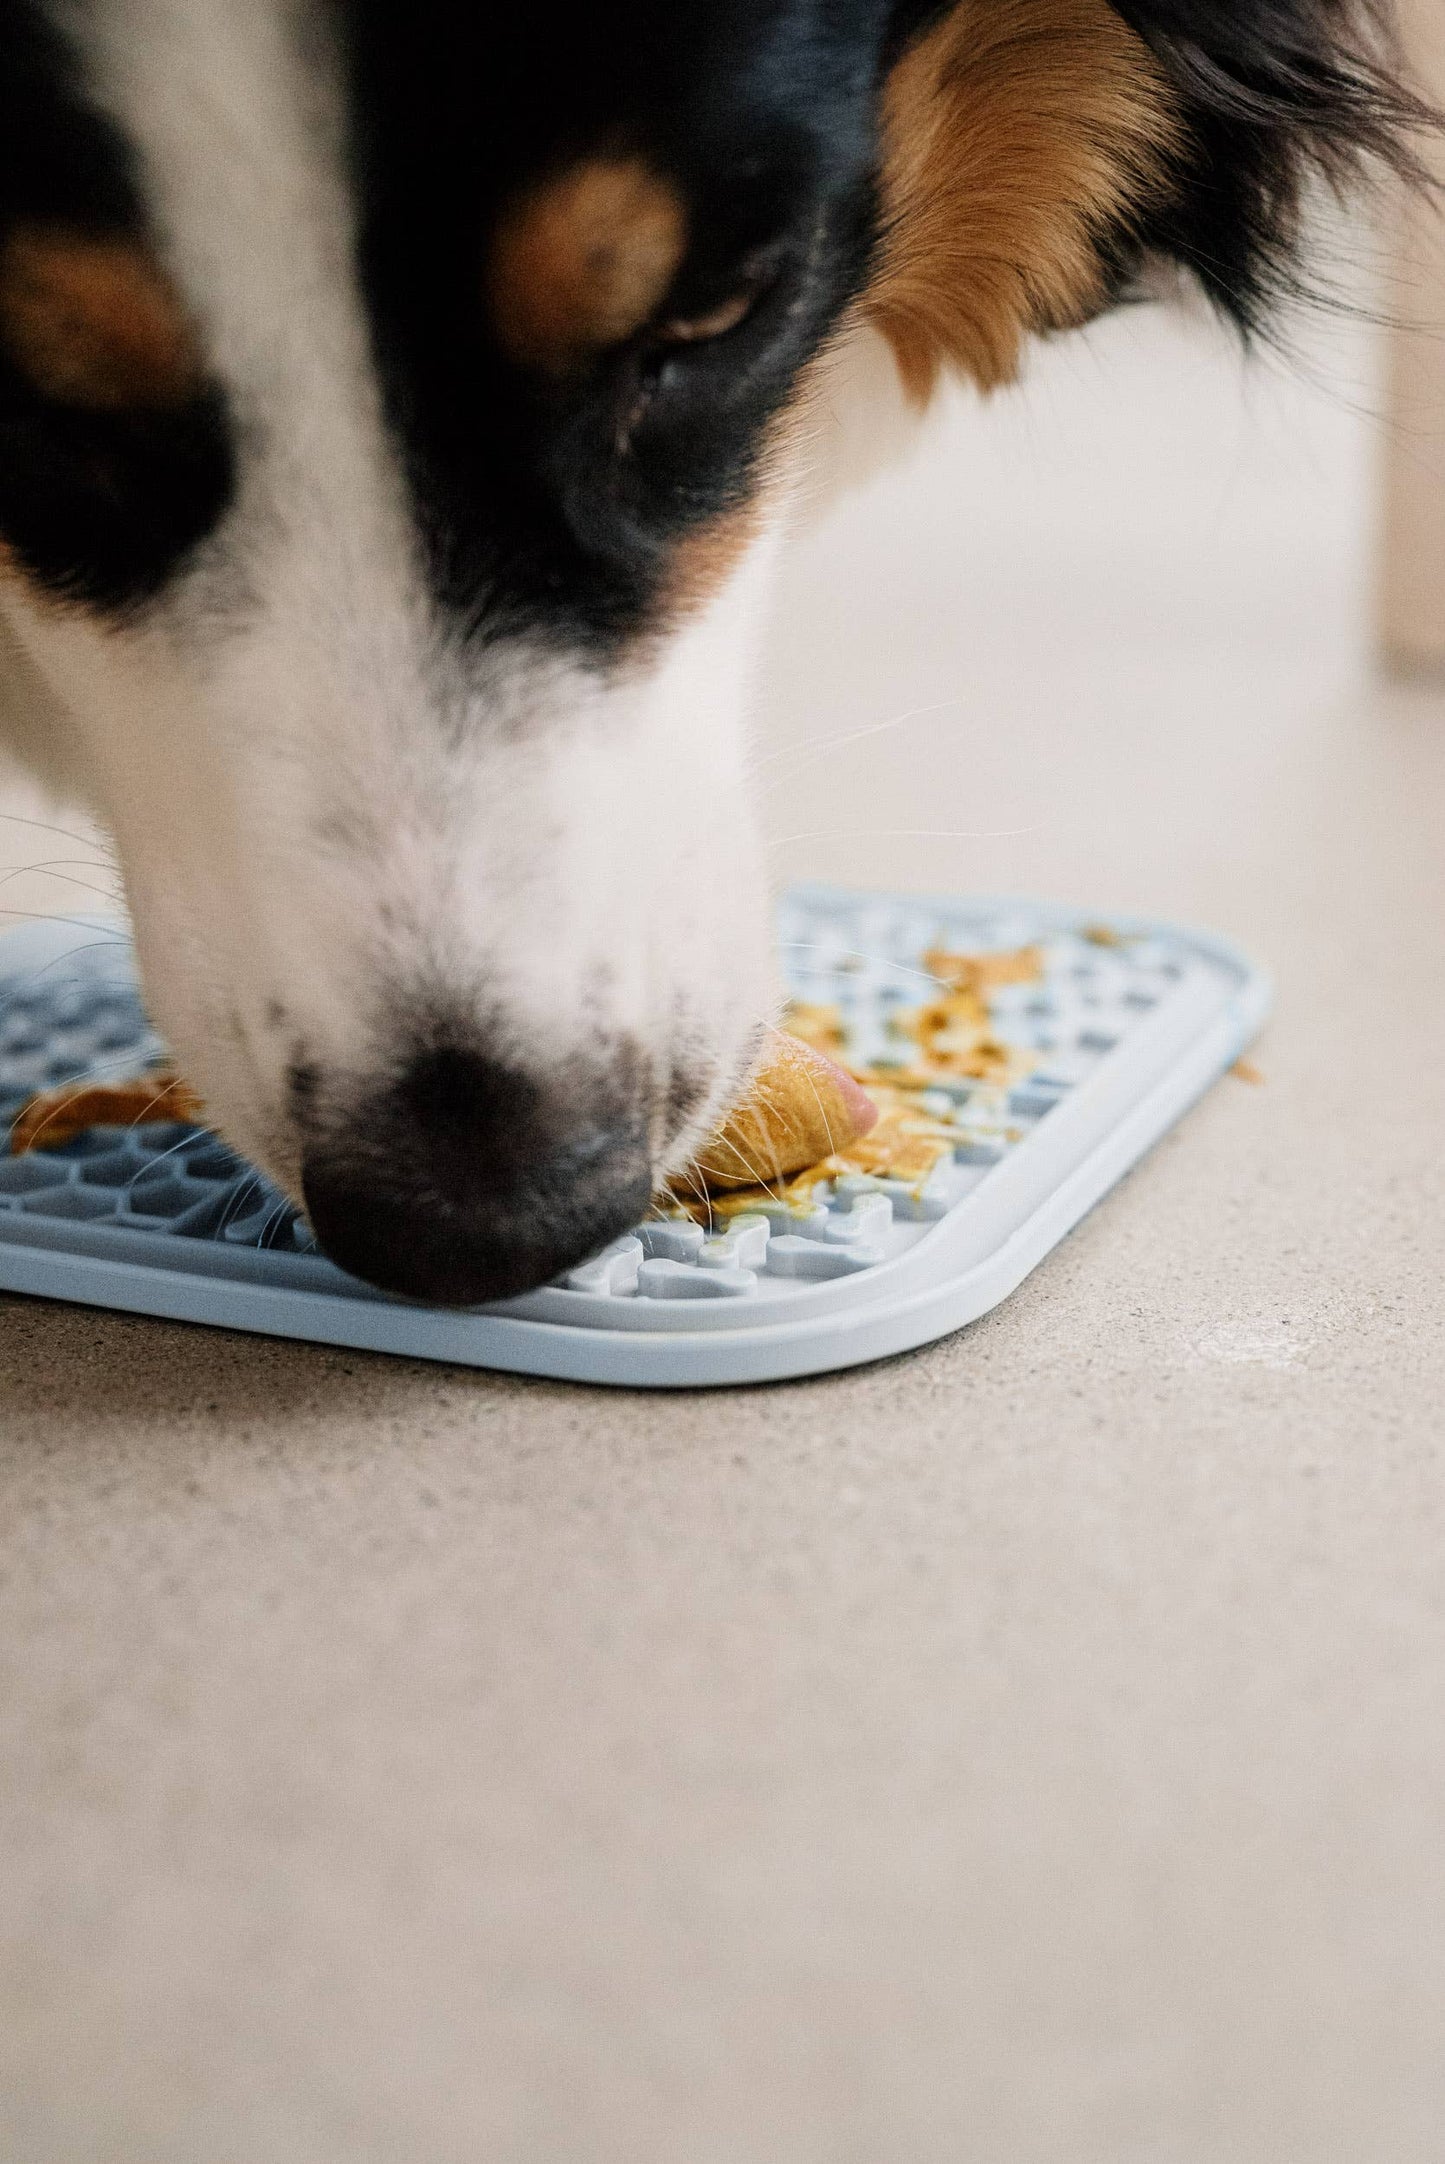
left=2, top=0, right=791, bottom=1188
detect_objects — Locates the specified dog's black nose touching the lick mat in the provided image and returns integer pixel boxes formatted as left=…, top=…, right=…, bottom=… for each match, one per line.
left=303, top=1050, right=651, bottom=1307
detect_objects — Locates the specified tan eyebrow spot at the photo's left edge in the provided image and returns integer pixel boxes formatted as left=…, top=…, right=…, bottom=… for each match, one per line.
left=0, top=225, right=199, bottom=411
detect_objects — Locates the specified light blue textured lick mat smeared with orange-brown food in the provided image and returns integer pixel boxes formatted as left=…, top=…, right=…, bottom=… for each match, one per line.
left=0, top=887, right=1270, bottom=1387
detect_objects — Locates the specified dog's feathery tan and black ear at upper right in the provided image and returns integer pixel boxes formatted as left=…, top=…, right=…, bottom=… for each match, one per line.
left=867, top=0, right=1434, bottom=396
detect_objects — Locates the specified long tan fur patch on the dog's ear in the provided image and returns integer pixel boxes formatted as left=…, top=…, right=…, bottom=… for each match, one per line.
left=865, top=0, right=1179, bottom=400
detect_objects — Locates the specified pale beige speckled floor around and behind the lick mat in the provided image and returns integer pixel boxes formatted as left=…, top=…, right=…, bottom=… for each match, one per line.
left=0, top=296, right=1445, bottom=2164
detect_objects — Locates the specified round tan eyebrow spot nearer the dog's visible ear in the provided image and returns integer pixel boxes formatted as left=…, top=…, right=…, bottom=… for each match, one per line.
left=487, top=158, right=688, bottom=377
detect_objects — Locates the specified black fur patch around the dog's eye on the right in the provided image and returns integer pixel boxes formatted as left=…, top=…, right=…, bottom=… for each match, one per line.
left=346, top=0, right=883, bottom=656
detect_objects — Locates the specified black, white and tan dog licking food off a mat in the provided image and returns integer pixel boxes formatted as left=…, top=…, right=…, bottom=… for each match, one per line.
left=0, top=0, right=1426, bottom=1305
